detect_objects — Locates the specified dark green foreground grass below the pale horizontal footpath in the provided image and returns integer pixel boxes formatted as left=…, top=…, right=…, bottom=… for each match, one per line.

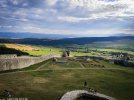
left=0, top=68, right=134, bottom=100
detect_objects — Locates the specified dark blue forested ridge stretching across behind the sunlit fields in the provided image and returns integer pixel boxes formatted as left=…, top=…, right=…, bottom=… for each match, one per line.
left=0, top=36, right=134, bottom=46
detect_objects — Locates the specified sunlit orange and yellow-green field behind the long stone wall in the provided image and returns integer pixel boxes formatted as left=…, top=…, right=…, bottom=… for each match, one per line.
left=0, top=43, right=62, bottom=56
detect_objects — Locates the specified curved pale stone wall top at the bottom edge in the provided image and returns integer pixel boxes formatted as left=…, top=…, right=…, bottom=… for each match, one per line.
left=60, top=90, right=116, bottom=100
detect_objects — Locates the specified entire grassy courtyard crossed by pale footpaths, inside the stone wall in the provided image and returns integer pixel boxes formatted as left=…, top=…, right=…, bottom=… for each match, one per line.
left=0, top=58, right=134, bottom=100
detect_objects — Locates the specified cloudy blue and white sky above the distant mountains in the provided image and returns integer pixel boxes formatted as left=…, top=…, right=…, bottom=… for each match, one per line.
left=0, top=0, right=134, bottom=37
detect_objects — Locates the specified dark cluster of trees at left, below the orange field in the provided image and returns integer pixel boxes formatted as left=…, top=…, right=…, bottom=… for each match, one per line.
left=0, top=46, right=29, bottom=56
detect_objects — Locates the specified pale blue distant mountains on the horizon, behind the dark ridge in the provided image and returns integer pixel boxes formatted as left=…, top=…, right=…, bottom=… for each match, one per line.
left=0, top=32, right=134, bottom=39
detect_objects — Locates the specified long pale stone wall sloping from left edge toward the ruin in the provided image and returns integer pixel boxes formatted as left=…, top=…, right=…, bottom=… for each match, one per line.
left=0, top=54, right=60, bottom=71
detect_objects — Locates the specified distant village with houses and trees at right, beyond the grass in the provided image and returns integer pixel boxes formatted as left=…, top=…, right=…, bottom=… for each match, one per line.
left=66, top=48, right=134, bottom=67
